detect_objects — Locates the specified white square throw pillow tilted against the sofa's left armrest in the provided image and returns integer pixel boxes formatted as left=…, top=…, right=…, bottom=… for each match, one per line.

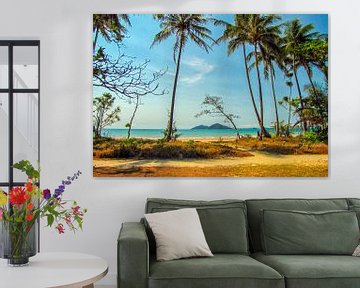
left=145, top=208, right=213, bottom=261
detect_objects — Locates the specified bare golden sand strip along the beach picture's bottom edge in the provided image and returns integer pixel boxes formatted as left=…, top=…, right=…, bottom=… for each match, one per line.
left=93, top=151, right=328, bottom=177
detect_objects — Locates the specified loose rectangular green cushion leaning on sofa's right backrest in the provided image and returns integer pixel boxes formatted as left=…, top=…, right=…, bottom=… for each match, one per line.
left=261, top=210, right=360, bottom=255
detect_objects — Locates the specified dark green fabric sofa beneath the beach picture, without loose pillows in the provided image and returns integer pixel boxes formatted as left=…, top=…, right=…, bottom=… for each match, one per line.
left=118, top=198, right=360, bottom=288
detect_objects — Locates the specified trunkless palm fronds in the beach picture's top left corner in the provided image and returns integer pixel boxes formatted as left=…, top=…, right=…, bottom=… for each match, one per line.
left=93, top=14, right=131, bottom=51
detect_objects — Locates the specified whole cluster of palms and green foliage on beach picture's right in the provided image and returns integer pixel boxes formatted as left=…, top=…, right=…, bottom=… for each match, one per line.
left=215, top=14, right=328, bottom=139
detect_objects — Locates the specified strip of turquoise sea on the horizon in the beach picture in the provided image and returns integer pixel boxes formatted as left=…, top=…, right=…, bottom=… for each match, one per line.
left=103, top=128, right=288, bottom=139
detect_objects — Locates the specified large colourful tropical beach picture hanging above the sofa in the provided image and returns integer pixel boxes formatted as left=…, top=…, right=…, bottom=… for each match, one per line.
left=92, top=14, right=329, bottom=177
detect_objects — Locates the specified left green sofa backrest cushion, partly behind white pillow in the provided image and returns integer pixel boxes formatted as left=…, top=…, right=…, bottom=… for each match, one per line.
left=145, top=198, right=249, bottom=254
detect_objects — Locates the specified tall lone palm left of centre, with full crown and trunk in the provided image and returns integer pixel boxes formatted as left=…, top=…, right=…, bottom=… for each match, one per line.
left=151, top=14, right=214, bottom=141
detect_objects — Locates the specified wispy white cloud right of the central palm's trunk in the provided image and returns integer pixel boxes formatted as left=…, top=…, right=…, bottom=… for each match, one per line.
left=180, top=57, right=215, bottom=84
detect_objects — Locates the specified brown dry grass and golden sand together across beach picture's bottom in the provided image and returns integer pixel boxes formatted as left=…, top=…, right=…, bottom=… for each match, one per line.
left=93, top=138, right=328, bottom=177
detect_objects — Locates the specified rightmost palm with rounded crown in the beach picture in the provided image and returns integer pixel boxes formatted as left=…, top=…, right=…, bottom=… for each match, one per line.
left=284, top=19, right=319, bottom=132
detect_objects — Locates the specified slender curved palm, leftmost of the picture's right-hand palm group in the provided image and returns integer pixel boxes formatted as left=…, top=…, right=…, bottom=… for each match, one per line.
left=214, top=14, right=270, bottom=137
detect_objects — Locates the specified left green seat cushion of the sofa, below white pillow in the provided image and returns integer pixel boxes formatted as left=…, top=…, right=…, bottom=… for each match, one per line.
left=149, top=254, right=285, bottom=288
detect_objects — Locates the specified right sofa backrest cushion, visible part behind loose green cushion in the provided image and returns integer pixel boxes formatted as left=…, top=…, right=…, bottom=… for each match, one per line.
left=246, top=199, right=348, bottom=252
